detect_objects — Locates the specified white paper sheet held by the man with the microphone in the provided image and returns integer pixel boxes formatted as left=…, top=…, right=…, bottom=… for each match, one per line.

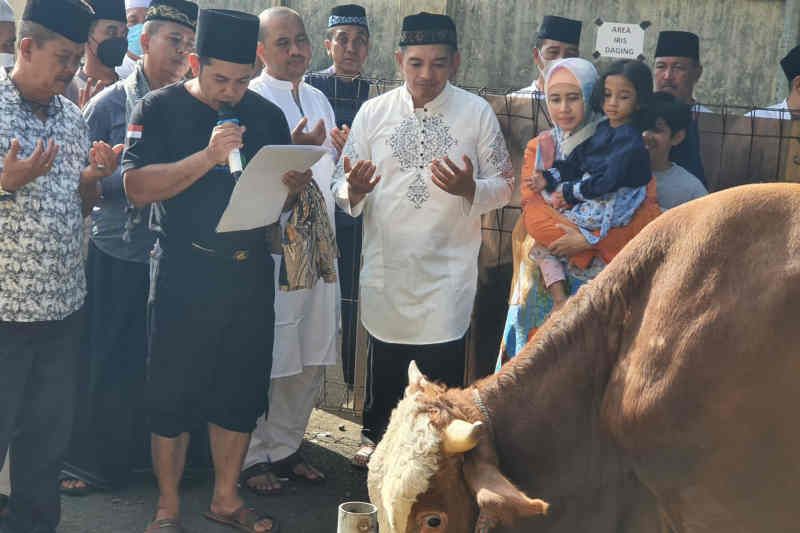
left=217, top=146, right=328, bottom=233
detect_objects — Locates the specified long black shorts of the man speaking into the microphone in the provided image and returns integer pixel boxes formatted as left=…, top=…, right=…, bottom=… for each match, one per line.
left=146, top=245, right=275, bottom=438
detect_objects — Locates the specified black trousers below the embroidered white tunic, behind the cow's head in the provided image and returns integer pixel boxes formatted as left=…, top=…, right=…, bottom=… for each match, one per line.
left=363, top=336, right=466, bottom=443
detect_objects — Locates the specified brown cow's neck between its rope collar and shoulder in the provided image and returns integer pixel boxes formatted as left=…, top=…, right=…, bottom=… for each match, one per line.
left=468, top=287, right=656, bottom=532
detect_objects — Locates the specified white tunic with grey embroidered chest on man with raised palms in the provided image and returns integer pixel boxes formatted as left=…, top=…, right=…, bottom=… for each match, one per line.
left=333, top=84, right=514, bottom=344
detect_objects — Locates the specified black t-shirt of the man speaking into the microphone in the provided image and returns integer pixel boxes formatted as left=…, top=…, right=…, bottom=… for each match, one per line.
left=122, top=82, right=292, bottom=250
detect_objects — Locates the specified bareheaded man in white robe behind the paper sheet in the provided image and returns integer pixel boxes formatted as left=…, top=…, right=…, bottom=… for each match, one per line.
left=243, top=8, right=339, bottom=493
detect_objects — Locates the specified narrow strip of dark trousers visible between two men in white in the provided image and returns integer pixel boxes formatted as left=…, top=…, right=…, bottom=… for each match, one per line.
left=336, top=207, right=363, bottom=387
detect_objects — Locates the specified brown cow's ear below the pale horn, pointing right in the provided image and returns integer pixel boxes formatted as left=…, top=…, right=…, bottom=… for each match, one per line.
left=464, top=454, right=549, bottom=526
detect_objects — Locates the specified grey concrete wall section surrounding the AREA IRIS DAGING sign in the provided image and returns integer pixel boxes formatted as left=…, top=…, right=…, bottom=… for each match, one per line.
left=448, top=0, right=786, bottom=105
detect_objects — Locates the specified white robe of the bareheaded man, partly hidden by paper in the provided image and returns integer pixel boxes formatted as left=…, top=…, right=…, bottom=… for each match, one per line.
left=250, top=72, right=339, bottom=378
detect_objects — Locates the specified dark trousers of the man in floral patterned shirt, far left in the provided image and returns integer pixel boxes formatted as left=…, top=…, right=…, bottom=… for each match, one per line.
left=0, top=311, right=83, bottom=533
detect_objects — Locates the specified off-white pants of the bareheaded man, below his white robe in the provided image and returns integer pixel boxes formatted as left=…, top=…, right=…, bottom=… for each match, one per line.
left=243, top=366, right=325, bottom=469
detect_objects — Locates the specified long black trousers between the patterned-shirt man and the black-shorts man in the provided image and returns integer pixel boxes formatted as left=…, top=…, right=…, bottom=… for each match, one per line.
left=64, top=243, right=150, bottom=487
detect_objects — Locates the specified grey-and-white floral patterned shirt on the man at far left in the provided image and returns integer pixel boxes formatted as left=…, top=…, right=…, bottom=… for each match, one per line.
left=0, top=68, right=89, bottom=322
